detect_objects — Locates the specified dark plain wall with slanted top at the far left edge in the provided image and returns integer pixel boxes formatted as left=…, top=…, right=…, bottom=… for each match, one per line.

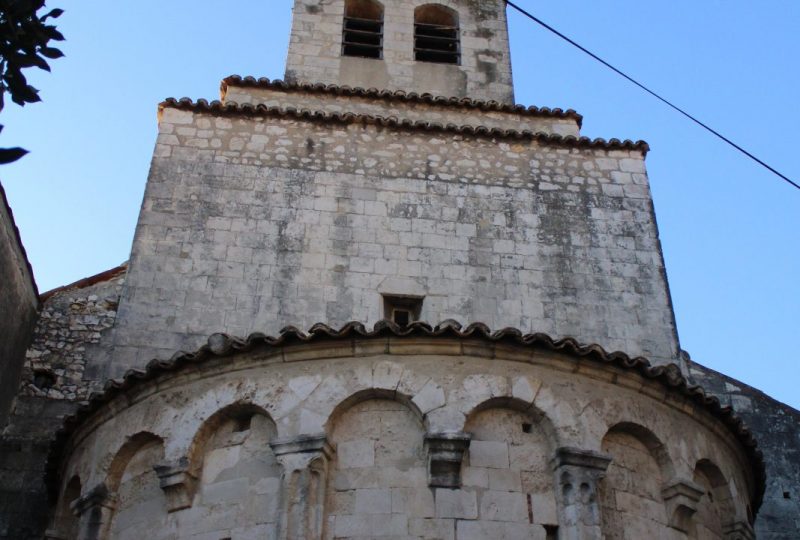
left=0, top=185, right=39, bottom=431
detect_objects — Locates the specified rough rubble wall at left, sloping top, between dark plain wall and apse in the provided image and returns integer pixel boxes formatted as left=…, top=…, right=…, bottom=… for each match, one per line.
left=0, top=274, right=124, bottom=540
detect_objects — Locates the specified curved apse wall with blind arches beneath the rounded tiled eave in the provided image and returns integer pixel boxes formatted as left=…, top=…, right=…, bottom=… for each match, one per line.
left=47, top=344, right=755, bottom=540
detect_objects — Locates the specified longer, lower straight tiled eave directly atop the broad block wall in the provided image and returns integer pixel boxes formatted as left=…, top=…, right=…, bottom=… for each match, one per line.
left=159, top=98, right=650, bottom=155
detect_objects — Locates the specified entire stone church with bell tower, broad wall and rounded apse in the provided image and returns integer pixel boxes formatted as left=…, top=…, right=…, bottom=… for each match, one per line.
left=0, top=0, right=800, bottom=540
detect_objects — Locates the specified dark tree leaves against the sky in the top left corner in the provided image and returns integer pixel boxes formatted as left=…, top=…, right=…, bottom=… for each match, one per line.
left=0, top=0, right=64, bottom=164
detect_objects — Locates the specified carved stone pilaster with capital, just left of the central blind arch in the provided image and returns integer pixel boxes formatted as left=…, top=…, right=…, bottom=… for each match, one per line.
left=270, top=435, right=333, bottom=540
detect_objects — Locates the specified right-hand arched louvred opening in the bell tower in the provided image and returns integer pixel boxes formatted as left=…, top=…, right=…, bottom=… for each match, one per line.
left=414, top=4, right=461, bottom=64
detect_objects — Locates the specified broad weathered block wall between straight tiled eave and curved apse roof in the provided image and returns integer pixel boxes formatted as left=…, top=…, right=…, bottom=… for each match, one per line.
left=110, top=107, right=677, bottom=375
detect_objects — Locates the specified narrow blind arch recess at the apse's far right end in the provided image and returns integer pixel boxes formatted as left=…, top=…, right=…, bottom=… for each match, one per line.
left=689, top=459, right=736, bottom=540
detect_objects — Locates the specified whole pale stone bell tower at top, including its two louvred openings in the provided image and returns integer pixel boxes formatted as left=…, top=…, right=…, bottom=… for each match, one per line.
left=286, top=0, right=514, bottom=104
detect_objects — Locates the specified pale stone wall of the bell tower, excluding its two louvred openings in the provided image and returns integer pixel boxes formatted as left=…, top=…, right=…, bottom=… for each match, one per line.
left=286, top=0, right=514, bottom=103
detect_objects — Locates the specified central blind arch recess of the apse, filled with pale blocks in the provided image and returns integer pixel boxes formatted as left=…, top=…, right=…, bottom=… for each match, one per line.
left=323, top=388, right=433, bottom=538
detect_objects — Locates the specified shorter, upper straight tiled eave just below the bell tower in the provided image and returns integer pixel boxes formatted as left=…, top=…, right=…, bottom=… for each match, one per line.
left=220, top=75, right=583, bottom=127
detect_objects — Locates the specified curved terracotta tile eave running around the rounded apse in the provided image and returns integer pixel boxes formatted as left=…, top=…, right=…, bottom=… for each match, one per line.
left=47, top=320, right=766, bottom=512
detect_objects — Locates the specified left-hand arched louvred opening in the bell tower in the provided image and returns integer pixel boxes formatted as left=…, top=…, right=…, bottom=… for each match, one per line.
left=342, top=0, right=383, bottom=58
